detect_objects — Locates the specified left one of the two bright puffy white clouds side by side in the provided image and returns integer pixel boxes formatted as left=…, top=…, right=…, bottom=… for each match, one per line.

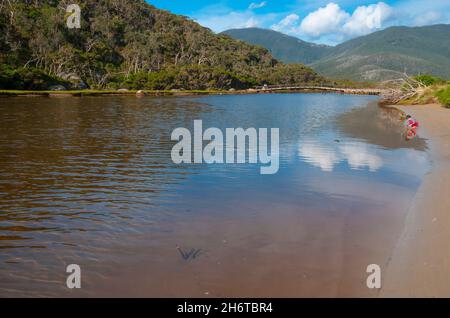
left=299, top=2, right=350, bottom=37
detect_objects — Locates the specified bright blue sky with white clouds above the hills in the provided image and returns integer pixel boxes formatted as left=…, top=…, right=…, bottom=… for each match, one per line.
left=147, top=0, right=450, bottom=45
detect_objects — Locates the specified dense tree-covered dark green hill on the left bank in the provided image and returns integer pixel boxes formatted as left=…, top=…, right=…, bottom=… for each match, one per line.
left=0, top=0, right=323, bottom=89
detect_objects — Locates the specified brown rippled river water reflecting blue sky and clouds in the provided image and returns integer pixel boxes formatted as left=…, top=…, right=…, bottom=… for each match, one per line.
left=0, top=94, right=430, bottom=297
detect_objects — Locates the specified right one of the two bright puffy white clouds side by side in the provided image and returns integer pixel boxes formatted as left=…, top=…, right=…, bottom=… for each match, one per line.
left=342, top=2, right=393, bottom=36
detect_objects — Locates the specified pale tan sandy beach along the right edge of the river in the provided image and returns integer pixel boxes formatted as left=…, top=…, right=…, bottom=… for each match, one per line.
left=380, top=104, right=450, bottom=297
